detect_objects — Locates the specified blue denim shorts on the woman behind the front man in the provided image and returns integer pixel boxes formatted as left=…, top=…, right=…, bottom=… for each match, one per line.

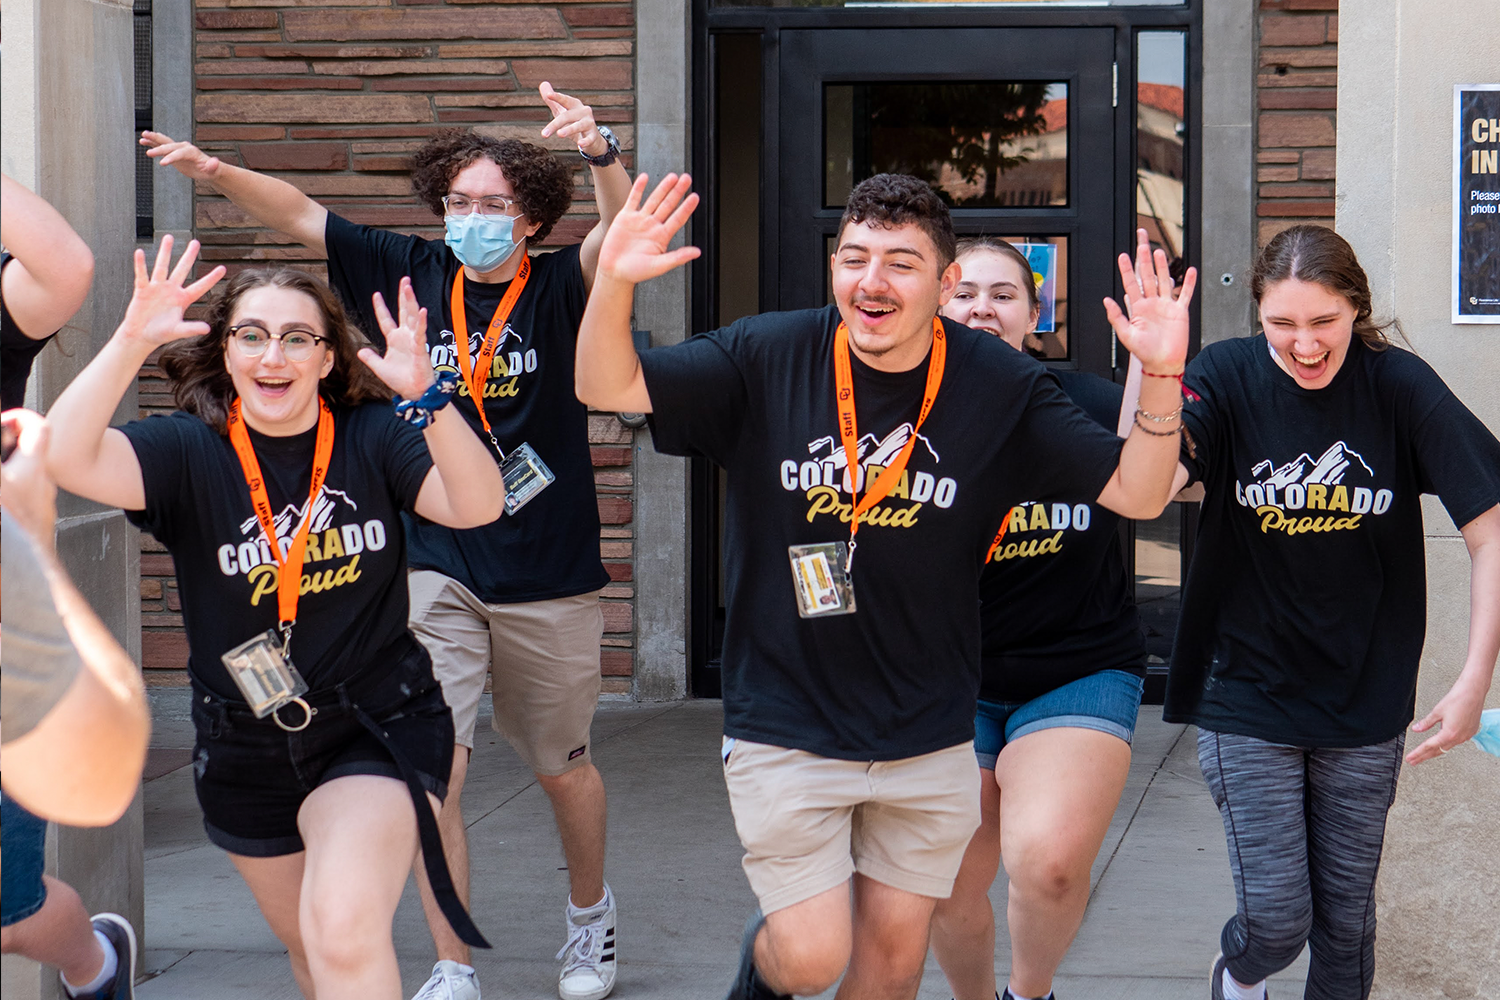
left=974, top=670, right=1143, bottom=771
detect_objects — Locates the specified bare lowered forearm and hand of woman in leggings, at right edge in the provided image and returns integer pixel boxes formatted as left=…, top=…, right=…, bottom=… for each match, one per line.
left=1407, top=505, right=1500, bottom=765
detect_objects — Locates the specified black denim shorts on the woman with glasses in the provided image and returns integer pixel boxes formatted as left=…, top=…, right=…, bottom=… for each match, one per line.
left=192, top=655, right=453, bottom=858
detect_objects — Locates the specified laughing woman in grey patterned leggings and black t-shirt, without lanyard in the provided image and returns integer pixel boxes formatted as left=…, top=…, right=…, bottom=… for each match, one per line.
left=1166, top=226, right=1500, bottom=1000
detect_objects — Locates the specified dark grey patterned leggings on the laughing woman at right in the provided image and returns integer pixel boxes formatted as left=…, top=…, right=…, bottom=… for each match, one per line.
left=1199, top=730, right=1406, bottom=1000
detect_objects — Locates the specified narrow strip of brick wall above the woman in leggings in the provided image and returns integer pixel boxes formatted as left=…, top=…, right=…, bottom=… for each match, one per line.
left=1256, top=0, right=1338, bottom=246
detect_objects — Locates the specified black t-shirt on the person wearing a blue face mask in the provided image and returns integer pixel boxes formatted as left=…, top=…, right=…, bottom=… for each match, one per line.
left=324, top=211, right=609, bottom=604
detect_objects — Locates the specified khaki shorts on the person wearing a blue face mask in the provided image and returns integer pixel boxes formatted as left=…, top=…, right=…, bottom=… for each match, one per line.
left=407, top=570, right=605, bottom=775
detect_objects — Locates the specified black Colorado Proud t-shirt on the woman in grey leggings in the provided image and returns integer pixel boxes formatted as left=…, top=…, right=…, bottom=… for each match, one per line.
left=1166, top=336, right=1500, bottom=747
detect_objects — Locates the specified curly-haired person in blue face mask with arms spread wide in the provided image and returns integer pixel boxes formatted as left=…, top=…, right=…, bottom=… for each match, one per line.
left=141, top=82, right=630, bottom=1000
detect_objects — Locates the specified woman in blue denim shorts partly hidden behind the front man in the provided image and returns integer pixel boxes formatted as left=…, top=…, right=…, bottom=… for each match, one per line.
left=932, top=238, right=1146, bottom=1000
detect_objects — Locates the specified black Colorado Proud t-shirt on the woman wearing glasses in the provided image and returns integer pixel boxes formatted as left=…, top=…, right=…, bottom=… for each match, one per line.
left=120, top=403, right=432, bottom=700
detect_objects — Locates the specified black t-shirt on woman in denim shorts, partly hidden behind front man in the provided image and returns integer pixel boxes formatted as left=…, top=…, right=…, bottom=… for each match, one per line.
left=980, top=372, right=1146, bottom=702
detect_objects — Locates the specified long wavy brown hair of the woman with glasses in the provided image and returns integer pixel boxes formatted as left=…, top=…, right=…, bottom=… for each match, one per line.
left=161, top=267, right=390, bottom=433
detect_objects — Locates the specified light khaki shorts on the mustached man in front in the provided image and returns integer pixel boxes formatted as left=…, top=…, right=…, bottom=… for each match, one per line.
left=723, top=738, right=980, bottom=913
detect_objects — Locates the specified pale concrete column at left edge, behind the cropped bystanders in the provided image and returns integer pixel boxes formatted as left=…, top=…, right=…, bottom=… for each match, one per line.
left=0, top=0, right=144, bottom=1000
